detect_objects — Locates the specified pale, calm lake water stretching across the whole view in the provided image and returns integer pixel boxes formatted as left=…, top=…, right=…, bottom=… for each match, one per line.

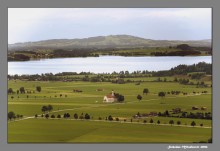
left=8, top=56, right=212, bottom=75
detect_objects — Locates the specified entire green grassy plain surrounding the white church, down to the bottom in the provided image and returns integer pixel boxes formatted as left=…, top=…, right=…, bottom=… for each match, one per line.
left=8, top=80, right=212, bottom=143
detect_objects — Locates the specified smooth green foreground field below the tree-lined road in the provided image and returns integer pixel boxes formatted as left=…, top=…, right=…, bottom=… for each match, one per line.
left=8, top=119, right=211, bottom=143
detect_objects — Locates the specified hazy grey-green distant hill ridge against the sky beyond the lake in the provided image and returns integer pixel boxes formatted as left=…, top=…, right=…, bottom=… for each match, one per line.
left=8, top=35, right=212, bottom=51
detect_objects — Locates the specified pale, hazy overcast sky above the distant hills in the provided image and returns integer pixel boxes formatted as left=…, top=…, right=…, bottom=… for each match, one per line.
left=8, top=8, right=212, bottom=44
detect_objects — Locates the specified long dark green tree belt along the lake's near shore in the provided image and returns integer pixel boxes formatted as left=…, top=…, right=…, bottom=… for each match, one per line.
left=8, top=62, right=212, bottom=82
